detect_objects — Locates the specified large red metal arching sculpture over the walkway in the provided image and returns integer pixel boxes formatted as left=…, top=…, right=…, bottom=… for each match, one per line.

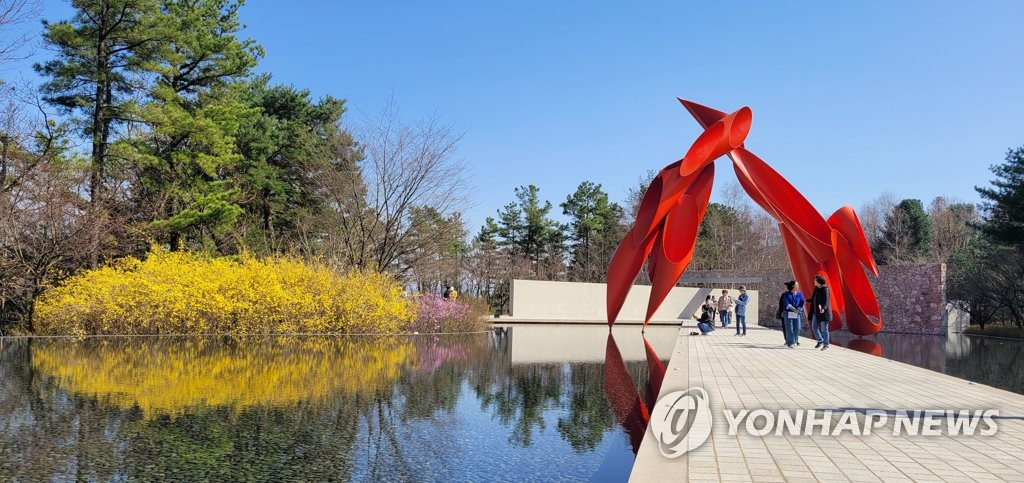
left=607, top=99, right=882, bottom=336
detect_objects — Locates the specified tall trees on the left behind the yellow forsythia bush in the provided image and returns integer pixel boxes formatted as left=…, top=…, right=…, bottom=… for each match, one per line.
left=0, top=0, right=468, bottom=328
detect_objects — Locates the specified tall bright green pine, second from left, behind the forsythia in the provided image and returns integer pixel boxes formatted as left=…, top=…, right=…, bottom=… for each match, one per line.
left=124, top=0, right=262, bottom=249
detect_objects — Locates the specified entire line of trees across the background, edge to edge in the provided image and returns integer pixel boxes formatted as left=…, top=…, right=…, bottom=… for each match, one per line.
left=0, top=0, right=1024, bottom=328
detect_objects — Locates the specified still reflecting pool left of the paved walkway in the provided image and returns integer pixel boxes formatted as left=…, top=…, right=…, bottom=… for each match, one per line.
left=0, top=325, right=677, bottom=481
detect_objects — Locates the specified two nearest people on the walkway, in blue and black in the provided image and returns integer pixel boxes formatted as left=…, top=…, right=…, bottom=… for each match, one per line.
left=775, top=275, right=833, bottom=350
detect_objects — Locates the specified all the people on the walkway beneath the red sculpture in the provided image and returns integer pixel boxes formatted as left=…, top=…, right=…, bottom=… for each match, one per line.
left=693, top=275, right=833, bottom=350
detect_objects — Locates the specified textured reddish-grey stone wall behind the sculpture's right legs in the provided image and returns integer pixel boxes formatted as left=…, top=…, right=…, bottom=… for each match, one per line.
left=683, top=264, right=946, bottom=334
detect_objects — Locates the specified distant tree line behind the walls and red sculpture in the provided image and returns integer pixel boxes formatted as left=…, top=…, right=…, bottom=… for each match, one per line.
left=452, top=176, right=983, bottom=313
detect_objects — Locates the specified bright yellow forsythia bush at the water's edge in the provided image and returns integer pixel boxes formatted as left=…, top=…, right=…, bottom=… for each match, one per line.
left=35, top=249, right=416, bottom=335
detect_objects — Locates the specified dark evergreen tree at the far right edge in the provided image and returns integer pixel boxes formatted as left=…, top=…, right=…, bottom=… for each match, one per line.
left=975, top=146, right=1024, bottom=249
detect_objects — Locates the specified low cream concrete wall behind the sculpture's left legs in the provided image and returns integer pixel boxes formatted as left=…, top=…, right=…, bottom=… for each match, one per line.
left=509, top=280, right=758, bottom=325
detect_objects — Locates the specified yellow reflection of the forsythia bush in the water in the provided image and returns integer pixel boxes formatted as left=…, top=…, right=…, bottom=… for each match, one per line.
left=32, top=337, right=415, bottom=419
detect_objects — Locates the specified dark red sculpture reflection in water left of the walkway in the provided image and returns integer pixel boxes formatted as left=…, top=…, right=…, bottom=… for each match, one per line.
left=604, top=332, right=665, bottom=454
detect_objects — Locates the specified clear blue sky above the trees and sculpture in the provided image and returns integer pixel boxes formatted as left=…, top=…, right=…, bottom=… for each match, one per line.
left=9, top=0, right=1024, bottom=232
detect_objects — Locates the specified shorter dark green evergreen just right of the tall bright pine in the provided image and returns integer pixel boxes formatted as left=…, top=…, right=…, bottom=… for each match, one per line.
left=233, top=77, right=362, bottom=251
